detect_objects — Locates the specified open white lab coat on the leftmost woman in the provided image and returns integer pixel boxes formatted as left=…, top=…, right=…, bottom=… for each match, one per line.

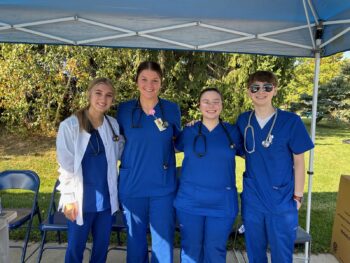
left=56, top=115, right=125, bottom=225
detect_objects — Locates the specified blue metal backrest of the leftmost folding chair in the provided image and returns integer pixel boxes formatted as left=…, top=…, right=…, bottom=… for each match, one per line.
left=0, top=170, right=40, bottom=193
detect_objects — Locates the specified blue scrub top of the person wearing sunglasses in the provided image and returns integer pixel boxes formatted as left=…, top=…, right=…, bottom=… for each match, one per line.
left=237, top=109, right=314, bottom=214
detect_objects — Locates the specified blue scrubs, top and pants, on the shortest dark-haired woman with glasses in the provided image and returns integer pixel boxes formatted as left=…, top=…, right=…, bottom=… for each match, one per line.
left=174, top=122, right=241, bottom=262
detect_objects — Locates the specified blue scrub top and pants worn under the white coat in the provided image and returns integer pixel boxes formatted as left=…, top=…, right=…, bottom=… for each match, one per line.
left=65, top=130, right=112, bottom=263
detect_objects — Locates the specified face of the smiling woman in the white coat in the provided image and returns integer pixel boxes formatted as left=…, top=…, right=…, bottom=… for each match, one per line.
left=89, top=83, right=114, bottom=114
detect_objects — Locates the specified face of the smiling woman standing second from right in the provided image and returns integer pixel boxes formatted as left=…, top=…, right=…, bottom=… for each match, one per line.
left=199, top=91, right=222, bottom=120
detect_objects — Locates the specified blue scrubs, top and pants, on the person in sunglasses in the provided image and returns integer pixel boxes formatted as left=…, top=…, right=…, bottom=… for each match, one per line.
left=237, top=109, right=313, bottom=263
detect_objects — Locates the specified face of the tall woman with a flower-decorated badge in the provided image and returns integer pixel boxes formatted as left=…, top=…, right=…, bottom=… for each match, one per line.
left=136, top=69, right=162, bottom=99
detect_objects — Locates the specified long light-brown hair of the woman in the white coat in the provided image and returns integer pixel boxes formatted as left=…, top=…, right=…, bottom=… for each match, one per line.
left=74, top=78, right=115, bottom=133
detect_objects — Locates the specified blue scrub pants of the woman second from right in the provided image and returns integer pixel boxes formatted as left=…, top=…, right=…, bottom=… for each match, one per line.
left=176, top=209, right=235, bottom=263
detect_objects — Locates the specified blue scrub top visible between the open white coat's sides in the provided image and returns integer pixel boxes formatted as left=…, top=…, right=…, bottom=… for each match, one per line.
left=81, top=130, right=111, bottom=213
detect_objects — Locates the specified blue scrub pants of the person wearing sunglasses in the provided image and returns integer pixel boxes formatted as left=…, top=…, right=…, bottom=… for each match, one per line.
left=243, top=206, right=298, bottom=263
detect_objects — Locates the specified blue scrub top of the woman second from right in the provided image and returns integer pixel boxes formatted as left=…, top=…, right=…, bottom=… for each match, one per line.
left=174, top=122, right=241, bottom=217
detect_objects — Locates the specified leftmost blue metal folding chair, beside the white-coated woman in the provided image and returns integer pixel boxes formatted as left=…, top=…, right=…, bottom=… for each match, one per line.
left=0, top=170, right=41, bottom=262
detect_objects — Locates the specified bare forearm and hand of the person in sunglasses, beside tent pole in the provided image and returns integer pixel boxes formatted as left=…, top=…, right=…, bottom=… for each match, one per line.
left=293, top=153, right=305, bottom=209
